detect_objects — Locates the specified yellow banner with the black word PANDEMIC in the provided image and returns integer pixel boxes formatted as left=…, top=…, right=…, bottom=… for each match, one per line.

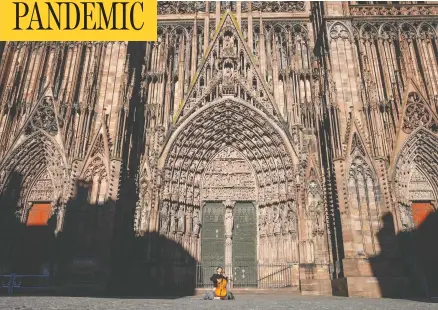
left=0, top=0, right=157, bottom=41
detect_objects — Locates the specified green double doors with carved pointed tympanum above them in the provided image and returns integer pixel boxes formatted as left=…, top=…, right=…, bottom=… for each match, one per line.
left=201, top=146, right=257, bottom=286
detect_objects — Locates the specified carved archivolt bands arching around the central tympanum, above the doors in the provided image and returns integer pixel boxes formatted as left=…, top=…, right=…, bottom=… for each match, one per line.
left=163, top=99, right=294, bottom=205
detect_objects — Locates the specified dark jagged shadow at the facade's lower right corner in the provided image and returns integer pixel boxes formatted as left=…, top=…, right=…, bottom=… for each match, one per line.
left=370, top=212, right=438, bottom=299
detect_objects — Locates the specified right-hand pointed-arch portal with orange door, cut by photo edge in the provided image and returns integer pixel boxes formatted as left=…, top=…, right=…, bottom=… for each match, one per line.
left=393, top=127, right=438, bottom=296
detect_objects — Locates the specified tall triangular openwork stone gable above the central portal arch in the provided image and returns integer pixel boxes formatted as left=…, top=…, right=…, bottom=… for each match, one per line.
left=177, top=14, right=279, bottom=122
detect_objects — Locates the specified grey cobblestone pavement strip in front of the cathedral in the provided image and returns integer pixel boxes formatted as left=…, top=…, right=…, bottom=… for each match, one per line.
left=0, top=295, right=438, bottom=310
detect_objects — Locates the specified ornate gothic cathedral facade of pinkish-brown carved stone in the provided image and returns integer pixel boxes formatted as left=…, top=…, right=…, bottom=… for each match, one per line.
left=0, top=1, right=438, bottom=296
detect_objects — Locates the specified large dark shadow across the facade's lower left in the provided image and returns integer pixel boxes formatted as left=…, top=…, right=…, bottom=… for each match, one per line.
left=0, top=179, right=196, bottom=297
